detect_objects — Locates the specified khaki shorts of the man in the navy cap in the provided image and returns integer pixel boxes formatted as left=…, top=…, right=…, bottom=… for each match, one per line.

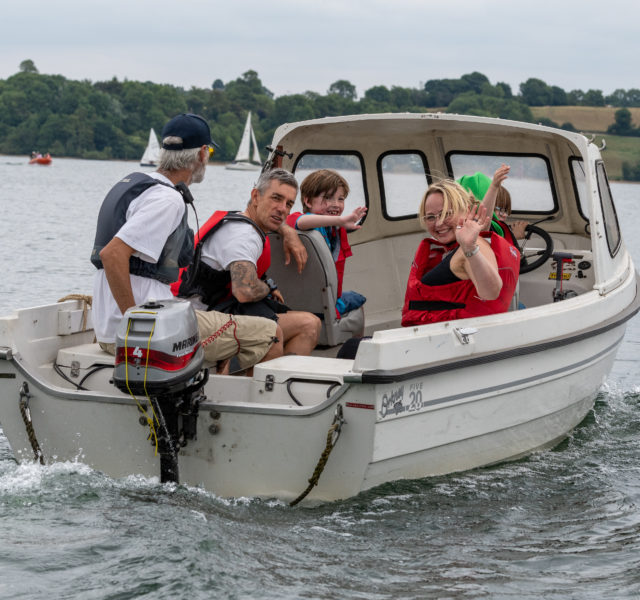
left=195, top=310, right=276, bottom=369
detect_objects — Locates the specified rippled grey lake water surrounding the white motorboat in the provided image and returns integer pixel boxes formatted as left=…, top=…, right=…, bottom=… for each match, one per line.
left=0, top=156, right=640, bottom=600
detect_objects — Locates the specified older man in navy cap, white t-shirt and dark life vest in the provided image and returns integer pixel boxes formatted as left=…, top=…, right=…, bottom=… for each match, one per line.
left=91, top=113, right=282, bottom=367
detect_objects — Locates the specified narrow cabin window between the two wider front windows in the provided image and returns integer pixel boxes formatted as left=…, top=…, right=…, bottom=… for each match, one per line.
left=378, top=151, right=429, bottom=221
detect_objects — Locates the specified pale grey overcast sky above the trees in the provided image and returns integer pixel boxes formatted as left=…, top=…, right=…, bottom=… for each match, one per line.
left=0, top=0, right=640, bottom=96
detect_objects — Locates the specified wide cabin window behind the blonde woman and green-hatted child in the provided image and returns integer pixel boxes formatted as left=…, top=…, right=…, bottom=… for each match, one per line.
left=447, top=152, right=558, bottom=214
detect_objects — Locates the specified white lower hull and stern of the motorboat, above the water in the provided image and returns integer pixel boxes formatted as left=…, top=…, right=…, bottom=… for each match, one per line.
left=0, top=304, right=624, bottom=501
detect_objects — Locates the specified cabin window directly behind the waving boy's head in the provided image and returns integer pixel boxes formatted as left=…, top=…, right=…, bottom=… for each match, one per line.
left=291, top=151, right=368, bottom=214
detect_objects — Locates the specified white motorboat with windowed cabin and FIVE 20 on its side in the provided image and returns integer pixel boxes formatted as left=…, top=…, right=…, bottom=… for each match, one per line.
left=0, top=114, right=640, bottom=501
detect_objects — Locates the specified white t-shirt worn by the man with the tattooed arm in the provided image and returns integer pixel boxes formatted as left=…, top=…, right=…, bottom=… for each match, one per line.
left=189, top=221, right=264, bottom=310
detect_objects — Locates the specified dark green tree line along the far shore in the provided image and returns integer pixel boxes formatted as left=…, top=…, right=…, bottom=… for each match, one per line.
left=0, top=60, right=640, bottom=161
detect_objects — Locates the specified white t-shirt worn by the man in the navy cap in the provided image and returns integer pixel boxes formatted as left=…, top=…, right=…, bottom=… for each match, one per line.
left=92, top=172, right=186, bottom=343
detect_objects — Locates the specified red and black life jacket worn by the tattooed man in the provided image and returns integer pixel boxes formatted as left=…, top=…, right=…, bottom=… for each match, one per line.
left=171, top=210, right=271, bottom=304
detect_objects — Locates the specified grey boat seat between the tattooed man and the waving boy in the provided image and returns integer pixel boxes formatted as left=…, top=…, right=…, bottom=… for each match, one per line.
left=268, top=230, right=364, bottom=346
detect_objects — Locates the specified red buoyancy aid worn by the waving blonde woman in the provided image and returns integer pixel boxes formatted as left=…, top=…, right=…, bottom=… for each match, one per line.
left=402, top=233, right=520, bottom=327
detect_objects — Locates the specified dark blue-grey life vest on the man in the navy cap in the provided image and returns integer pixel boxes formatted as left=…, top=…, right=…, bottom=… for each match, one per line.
left=91, top=173, right=193, bottom=285
